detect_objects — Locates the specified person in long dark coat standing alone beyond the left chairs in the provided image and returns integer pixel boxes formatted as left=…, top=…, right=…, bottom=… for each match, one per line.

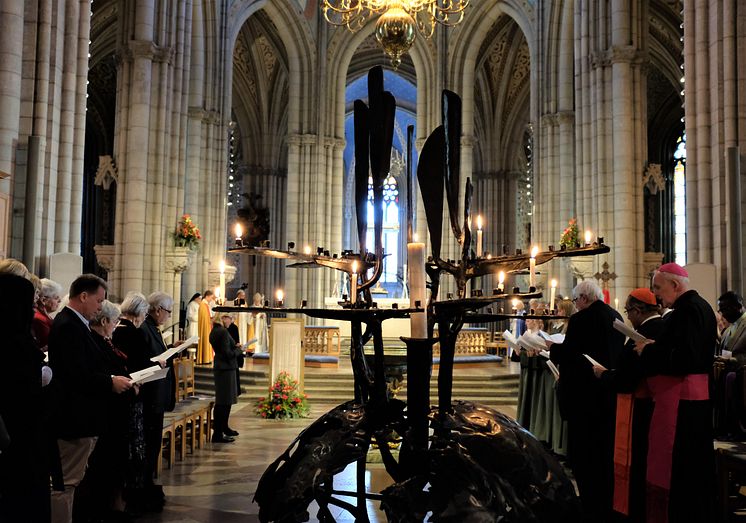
left=210, top=322, right=243, bottom=443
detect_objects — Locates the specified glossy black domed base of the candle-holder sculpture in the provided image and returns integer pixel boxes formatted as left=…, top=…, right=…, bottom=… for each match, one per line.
left=255, top=401, right=580, bottom=523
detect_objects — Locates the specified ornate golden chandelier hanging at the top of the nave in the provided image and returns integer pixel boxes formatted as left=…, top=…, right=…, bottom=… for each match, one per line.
left=321, top=0, right=470, bottom=69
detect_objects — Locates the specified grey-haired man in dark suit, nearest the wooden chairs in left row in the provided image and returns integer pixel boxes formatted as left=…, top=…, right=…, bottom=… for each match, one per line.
left=140, top=291, right=176, bottom=510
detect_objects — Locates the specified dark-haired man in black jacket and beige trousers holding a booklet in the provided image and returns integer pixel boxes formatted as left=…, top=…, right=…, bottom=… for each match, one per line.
left=49, top=274, right=132, bottom=523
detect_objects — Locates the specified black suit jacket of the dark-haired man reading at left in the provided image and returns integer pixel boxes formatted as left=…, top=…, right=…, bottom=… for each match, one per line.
left=49, top=307, right=113, bottom=439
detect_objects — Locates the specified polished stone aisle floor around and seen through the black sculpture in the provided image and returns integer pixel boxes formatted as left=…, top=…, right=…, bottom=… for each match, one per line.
left=138, top=367, right=515, bottom=523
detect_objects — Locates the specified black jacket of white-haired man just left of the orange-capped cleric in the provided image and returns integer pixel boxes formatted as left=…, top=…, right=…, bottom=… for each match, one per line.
left=550, top=300, right=624, bottom=419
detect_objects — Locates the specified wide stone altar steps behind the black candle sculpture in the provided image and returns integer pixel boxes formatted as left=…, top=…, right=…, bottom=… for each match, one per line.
left=195, top=367, right=518, bottom=407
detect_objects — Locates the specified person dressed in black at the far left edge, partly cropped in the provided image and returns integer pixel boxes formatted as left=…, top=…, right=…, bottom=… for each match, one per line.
left=0, top=272, right=50, bottom=522
